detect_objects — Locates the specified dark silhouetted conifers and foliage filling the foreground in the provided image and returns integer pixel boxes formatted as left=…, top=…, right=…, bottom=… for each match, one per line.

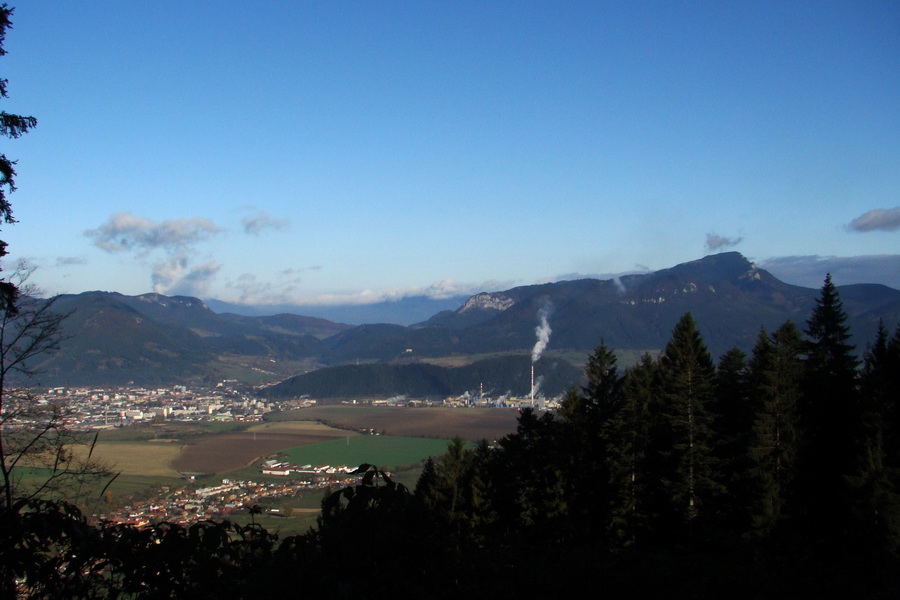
left=0, top=278, right=900, bottom=598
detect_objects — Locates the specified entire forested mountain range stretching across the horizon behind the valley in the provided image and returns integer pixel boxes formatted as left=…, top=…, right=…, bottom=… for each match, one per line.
left=17, top=252, right=900, bottom=393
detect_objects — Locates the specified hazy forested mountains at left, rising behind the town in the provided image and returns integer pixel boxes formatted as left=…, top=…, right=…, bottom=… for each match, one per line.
left=24, top=292, right=349, bottom=385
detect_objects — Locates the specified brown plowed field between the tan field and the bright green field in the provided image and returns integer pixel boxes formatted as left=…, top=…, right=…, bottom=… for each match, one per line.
left=172, top=431, right=344, bottom=473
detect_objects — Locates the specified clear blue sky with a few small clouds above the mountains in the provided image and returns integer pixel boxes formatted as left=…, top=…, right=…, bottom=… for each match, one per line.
left=0, top=0, right=900, bottom=303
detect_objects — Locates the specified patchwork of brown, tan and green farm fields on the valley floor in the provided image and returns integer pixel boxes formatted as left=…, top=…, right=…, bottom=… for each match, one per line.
left=23, top=405, right=518, bottom=510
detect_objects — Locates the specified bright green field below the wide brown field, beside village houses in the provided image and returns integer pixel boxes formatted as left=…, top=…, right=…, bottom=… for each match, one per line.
left=284, top=435, right=447, bottom=468
